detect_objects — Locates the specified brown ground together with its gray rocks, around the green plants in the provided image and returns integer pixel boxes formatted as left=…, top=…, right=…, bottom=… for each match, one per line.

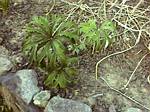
left=0, top=0, right=150, bottom=112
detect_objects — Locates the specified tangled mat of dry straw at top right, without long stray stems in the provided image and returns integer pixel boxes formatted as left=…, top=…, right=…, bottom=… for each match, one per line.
left=56, top=0, right=150, bottom=48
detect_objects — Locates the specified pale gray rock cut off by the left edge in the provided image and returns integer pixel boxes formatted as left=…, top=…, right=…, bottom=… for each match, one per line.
left=0, top=56, right=13, bottom=75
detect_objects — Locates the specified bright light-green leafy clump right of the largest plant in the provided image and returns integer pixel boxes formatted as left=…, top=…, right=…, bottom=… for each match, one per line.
left=80, top=19, right=116, bottom=51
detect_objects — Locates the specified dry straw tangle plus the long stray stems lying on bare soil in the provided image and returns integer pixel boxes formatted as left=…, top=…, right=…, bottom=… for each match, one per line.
left=54, top=0, right=150, bottom=110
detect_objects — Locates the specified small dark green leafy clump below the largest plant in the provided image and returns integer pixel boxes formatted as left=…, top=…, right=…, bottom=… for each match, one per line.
left=45, top=58, right=77, bottom=88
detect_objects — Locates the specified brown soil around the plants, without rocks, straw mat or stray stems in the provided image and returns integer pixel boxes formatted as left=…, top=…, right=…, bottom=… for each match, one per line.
left=0, top=1, right=150, bottom=112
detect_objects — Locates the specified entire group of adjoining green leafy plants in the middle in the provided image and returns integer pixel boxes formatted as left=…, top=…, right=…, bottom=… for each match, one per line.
left=23, top=15, right=115, bottom=88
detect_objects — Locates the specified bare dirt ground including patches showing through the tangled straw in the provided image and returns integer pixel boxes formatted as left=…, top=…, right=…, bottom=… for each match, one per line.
left=0, top=0, right=150, bottom=112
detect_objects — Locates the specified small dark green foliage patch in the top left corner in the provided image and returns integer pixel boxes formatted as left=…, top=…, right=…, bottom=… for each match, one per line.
left=0, top=0, right=10, bottom=13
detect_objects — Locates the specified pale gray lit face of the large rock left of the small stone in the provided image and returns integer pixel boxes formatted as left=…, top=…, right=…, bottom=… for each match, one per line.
left=16, top=70, right=39, bottom=104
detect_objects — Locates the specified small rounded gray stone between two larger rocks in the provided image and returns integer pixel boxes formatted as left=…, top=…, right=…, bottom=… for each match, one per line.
left=33, top=90, right=50, bottom=107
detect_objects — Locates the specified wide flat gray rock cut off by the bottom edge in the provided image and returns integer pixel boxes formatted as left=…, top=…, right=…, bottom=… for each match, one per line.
left=44, top=96, right=92, bottom=112
